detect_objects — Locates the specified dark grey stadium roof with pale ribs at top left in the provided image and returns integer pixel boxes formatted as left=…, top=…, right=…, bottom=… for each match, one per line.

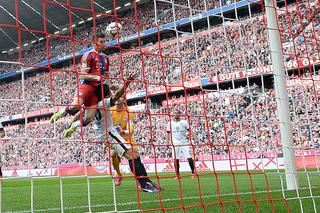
left=0, top=0, right=133, bottom=50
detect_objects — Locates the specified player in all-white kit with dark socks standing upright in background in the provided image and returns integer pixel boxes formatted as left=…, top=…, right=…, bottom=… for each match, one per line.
left=167, top=110, right=199, bottom=179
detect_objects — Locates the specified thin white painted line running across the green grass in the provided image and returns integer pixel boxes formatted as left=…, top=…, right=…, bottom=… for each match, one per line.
left=4, top=187, right=318, bottom=213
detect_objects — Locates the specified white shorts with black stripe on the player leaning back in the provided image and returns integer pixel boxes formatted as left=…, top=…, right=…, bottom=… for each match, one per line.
left=100, top=130, right=132, bottom=157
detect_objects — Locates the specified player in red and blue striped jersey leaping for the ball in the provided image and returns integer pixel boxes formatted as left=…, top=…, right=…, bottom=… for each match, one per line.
left=50, top=33, right=109, bottom=126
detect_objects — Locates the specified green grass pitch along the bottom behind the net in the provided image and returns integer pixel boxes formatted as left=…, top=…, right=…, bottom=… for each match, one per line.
left=1, top=170, right=320, bottom=212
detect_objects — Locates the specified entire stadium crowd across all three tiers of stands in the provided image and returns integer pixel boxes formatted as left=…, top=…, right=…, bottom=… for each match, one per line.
left=0, top=0, right=320, bottom=168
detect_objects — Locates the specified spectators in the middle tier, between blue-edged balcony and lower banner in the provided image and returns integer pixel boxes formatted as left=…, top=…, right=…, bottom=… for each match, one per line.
left=0, top=0, right=320, bottom=115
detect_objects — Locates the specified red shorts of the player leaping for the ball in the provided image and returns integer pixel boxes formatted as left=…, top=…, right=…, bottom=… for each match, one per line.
left=79, top=84, right=99, bottom=107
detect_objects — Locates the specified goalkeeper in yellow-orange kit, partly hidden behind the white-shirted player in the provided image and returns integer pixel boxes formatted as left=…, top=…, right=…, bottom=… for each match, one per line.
left=110, top=98, right=137, bottom=186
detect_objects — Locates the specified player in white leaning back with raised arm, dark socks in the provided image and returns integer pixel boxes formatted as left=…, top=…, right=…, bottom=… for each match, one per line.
left=65, top=75, right=160, bottom=192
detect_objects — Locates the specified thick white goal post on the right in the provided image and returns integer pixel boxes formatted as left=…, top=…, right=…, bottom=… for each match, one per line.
left=264, top=0, right=299, bottom=190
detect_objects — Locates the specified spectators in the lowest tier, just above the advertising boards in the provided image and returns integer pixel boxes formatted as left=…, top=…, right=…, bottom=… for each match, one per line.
left=1, top=77, right=320, bottom=168
